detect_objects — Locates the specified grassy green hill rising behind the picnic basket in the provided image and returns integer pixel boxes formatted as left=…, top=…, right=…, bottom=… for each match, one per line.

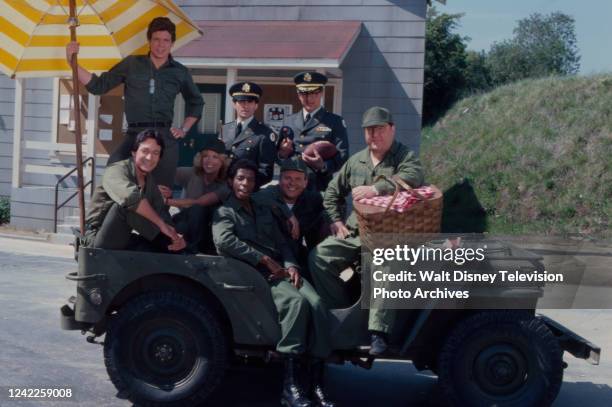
left=421, top=75, right=612, bottom=236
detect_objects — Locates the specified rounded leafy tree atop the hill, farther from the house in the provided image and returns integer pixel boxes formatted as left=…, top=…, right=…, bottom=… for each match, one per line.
left=487, top=12, right=580, bottom=85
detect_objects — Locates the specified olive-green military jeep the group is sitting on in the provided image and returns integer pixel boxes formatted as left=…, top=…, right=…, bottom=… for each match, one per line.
left=61, top=239, right=600, bottom=407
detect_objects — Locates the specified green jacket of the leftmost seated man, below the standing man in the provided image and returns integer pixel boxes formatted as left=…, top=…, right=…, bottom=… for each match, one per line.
left=85, top=158, right=170, bottom=229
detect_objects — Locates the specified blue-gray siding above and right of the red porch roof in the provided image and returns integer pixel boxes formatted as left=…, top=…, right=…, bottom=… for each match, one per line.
left=177, top=0, right=427, bottom=152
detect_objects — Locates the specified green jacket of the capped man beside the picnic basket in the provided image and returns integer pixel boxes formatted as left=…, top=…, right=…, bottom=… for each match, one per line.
left=323, top=141, right=423, bottom=230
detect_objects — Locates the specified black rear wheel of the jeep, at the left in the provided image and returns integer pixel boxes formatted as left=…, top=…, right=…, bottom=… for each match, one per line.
left=104, top=292, right=228, bottom=406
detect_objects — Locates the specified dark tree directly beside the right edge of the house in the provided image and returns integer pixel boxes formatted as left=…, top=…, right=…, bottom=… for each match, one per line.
left=423, top=7, right=468, bottom=123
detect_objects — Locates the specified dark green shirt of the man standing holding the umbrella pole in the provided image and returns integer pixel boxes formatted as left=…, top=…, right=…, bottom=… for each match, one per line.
left=86, top=55, right=204, bottom=123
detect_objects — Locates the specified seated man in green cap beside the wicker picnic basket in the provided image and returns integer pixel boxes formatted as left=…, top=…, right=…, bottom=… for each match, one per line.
left=308, top=107, right=423, bottom=355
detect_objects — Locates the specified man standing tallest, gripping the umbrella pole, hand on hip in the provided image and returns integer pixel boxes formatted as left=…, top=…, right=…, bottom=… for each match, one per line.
left=66, top=17, right=204, bottom=188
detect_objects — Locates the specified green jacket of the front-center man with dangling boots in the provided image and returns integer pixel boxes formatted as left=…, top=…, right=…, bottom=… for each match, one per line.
left=213, top=194, right=299, bottom=269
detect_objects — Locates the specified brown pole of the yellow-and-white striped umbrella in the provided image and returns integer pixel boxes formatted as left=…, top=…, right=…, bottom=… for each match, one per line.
left=70, top=0, right=85, bottom=234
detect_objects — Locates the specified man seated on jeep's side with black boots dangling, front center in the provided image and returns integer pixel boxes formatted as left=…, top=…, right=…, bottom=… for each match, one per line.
left=213, top=159, right=331, bottom=407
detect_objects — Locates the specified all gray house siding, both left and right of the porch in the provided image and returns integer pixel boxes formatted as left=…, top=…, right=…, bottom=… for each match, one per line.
left=0, top=0, right=427, bottom=230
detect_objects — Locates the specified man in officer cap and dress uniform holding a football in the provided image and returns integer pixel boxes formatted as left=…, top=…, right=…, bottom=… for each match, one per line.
left=278, top=72, right=348, bottom=191
